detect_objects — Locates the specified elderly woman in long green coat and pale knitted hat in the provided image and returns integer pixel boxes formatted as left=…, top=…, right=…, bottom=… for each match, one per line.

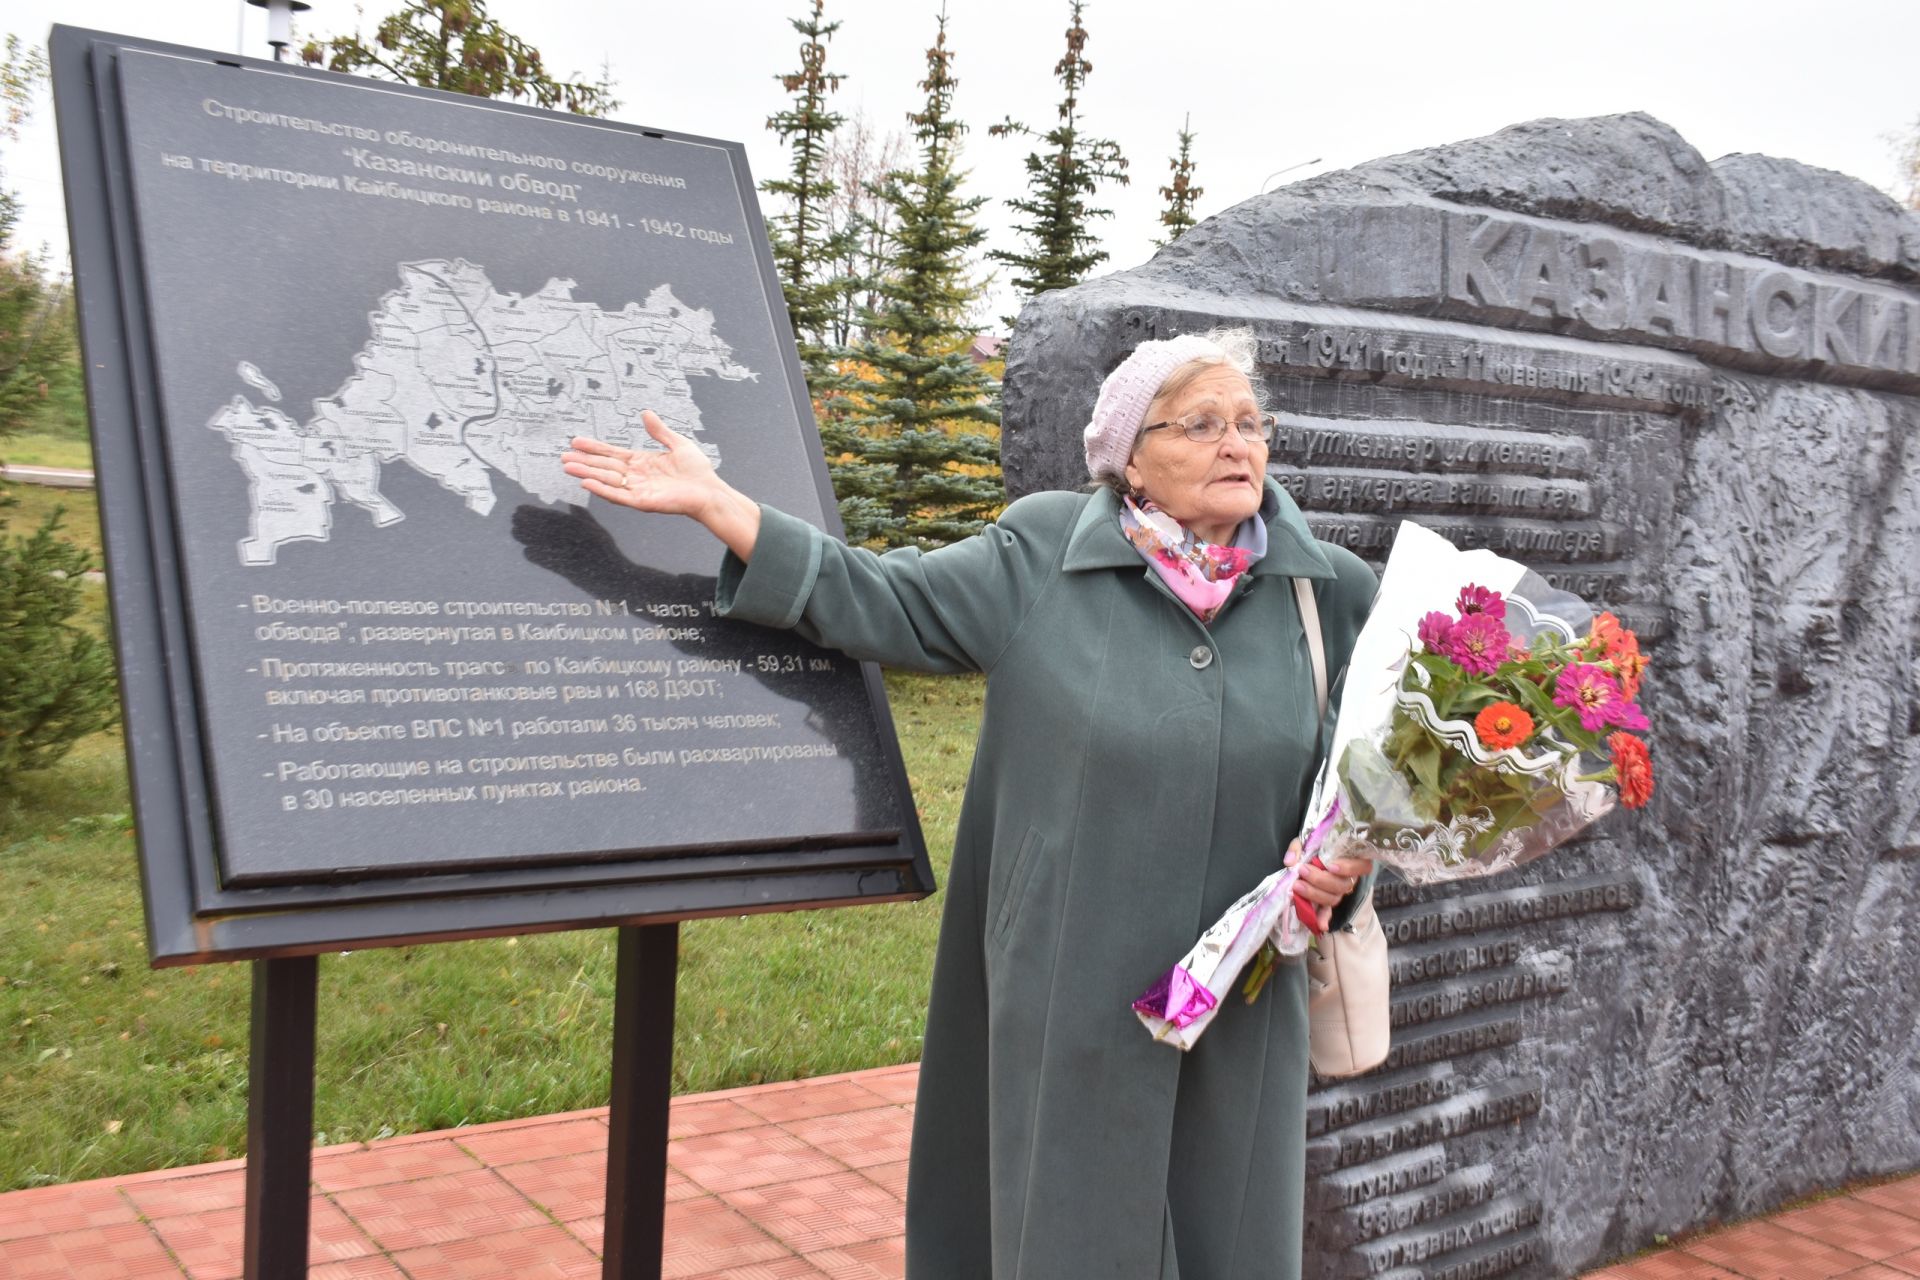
left=564, top=332, right=1375, bottom=1280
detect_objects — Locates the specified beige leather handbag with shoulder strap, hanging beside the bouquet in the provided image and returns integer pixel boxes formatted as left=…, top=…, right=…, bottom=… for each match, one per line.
left=1294, top=578, right=1392, bottom=1077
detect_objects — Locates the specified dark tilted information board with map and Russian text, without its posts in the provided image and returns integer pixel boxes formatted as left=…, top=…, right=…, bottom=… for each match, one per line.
left=54, top=29, right=931, bottom=960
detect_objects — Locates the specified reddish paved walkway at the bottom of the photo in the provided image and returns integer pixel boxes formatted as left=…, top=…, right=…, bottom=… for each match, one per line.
left=0, top=1065, right=1920, bottom=1280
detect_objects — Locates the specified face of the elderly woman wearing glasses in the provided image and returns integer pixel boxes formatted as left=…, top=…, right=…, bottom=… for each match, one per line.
left=1127, top=365, right=1267, bottom=543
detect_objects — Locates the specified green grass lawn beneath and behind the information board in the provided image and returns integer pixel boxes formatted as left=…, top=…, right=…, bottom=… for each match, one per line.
left=0, top=671, right=985, bottom=1190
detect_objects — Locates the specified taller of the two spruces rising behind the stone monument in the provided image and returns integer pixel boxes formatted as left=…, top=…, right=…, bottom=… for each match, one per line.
left=987, top=0, right=1127, bottom=297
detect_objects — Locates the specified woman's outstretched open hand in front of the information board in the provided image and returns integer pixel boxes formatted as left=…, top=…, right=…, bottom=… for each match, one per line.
left=561, top=409, right=760, bottom=560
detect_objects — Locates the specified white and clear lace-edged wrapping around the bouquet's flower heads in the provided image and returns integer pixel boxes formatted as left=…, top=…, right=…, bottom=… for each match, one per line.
left=1306, top=520, right=1617, bottom=885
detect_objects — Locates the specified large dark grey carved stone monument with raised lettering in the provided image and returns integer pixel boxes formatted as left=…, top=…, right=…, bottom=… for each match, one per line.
left=1004, top=115, right=1920, bottom=1280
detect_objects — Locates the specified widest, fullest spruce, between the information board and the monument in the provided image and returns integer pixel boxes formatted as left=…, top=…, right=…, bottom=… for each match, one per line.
left=824, top=10, right=1004, bottom=547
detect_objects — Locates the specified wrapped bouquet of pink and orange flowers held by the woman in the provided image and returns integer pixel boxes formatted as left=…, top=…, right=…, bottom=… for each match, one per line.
left=1133, top=522, right=1653, bottom=1048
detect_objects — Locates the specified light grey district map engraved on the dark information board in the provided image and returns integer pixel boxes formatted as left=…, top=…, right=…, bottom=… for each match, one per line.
left=207, top=259, right=758, bottom=564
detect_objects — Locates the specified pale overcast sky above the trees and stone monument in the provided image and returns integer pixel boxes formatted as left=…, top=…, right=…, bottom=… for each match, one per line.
left=0, top=0, right=1920, bottom=315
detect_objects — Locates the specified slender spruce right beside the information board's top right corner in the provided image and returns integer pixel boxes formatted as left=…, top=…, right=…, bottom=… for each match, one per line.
left=760, top=0, right=858, bottom=370
